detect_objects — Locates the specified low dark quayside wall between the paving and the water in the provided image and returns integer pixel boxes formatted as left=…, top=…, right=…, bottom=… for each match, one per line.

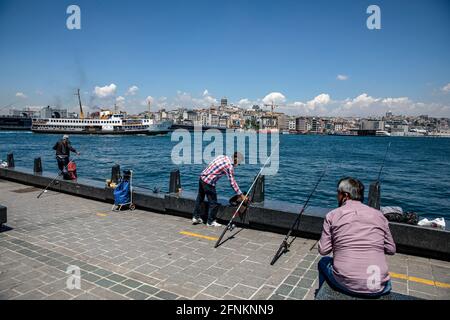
left=0, top=168, right=450, bottom=261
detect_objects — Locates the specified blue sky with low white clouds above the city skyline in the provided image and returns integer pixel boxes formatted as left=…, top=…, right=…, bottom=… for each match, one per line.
left=0, top=0, right=450, bottom=117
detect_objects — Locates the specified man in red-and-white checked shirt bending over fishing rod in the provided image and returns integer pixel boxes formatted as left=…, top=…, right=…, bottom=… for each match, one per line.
left=192, top=152, right=245, bottom=227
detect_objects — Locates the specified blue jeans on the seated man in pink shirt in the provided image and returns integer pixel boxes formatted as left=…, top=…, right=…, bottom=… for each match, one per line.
left=318, top=257, right=392, bottom=298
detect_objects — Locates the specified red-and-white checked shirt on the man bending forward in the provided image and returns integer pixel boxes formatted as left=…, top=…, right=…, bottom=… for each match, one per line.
left=200, top=156, right=242, bottom=194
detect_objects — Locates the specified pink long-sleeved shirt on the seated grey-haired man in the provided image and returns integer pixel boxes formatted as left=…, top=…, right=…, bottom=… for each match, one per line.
left=319, top=200, right=395, bottom=293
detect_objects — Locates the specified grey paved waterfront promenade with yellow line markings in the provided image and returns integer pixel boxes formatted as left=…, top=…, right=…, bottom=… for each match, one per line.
left=0, top=180, right=450, bottom=300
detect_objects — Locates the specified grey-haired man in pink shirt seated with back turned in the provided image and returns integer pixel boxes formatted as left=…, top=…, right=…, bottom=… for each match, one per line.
left=318, top=178, right=395, bottom=297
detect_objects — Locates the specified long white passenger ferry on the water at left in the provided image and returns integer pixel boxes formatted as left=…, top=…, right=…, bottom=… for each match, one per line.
left=31, top=114, right=172, bottom=135
